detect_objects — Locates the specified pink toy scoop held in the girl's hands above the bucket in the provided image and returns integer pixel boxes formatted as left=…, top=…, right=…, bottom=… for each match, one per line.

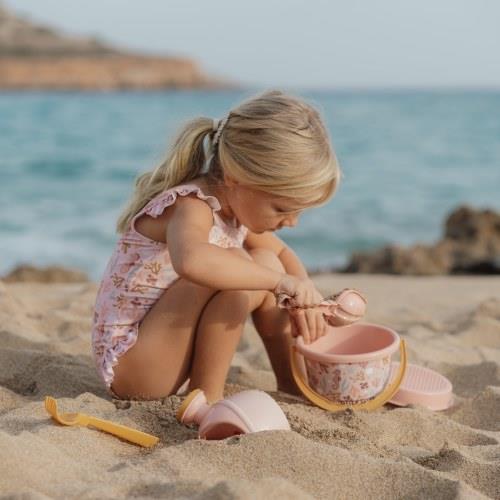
left=276, top=288, right=366, bottom=326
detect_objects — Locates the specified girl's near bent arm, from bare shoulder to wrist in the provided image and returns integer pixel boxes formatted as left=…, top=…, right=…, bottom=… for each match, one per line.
left=166, top=196, right=285, bottom=290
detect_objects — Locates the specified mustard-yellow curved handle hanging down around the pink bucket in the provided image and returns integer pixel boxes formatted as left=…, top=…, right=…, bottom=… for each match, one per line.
left=290, top=339, right=407, bottom=411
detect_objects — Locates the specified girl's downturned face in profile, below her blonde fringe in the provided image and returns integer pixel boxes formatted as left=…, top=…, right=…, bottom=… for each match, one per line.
left=227, top=184, right=304, bottom=233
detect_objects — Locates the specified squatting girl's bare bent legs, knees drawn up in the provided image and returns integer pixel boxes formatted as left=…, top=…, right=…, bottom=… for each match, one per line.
left=111, top=249, right=297, bottom=401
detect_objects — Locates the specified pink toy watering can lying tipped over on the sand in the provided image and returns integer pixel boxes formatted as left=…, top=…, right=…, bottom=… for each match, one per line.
left=177, top=389, right=290, bottom=439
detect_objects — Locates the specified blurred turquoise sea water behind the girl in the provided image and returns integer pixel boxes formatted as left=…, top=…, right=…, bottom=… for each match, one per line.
left=0, top=90, right=500, bottom=279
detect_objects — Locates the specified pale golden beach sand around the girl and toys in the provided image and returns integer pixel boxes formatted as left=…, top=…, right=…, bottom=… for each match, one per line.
left=0, top=274, right=500, bottom=500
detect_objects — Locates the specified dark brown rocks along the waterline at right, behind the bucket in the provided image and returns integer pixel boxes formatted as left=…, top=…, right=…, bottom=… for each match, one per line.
left=340, top=206, right=500, bottom=275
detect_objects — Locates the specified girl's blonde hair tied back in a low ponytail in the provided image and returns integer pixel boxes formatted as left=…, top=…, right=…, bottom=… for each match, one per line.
left=117, top=90, right=340, bottom=233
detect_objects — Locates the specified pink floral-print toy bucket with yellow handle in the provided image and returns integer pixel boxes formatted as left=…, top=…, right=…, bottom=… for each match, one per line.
left=292, top=323, right=406, bottom=410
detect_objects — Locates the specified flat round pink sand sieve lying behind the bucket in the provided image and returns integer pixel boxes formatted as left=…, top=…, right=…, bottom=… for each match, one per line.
left=389, top=361, right=453, bottom=411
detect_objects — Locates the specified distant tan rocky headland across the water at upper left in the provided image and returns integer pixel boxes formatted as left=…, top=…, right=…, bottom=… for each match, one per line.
left=0, top=4, right=232, bottom=90
